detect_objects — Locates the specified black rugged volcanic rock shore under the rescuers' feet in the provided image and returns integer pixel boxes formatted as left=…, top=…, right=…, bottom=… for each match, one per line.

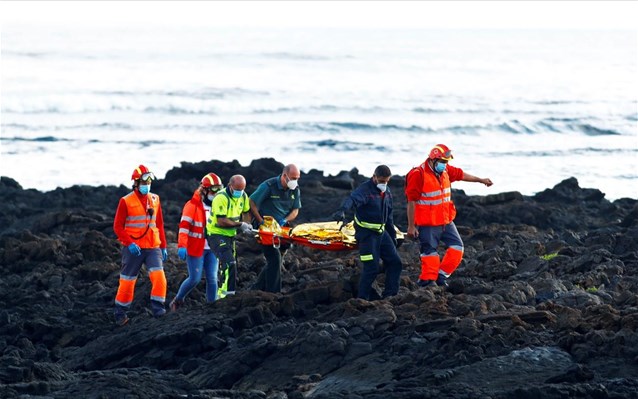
left=0, top=159, right=638, bottom=399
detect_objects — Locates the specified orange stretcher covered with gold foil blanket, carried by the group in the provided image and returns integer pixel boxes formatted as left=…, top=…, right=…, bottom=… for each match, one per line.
left=255, top=216, right=404, bottom=251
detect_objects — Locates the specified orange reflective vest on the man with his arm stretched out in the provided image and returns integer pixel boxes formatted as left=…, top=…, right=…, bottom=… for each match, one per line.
left=414, top=163, right=456, bottom=226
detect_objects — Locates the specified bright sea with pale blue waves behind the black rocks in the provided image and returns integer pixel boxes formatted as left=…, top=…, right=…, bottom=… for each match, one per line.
left=0, top=26, right=638, bottom=200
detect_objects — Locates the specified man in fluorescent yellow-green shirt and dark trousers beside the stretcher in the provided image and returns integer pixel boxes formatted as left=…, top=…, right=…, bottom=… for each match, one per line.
left=206, top=175, right=252, bottom=298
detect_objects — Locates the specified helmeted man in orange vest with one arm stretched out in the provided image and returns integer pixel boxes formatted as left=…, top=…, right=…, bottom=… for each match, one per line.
left=405, top=144, right=492, bottom=287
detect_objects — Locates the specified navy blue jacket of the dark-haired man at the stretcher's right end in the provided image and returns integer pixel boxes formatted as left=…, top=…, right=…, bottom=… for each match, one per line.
left=341, top=179, right=396, bottom=240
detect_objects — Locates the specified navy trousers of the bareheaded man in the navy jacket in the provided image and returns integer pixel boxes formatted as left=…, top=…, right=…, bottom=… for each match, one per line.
left=355, top=228, right=403, bottom=300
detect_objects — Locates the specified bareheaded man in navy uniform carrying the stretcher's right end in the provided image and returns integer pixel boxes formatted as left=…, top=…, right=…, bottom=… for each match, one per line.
left=333, top=165, right=403, bottom=300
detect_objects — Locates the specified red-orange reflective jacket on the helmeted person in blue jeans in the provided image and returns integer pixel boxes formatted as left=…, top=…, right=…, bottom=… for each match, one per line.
left=177, top=190, right=207, bottom=257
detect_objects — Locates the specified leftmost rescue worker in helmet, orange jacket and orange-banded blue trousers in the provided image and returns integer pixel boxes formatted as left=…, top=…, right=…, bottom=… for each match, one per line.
left=113, top=165, right=168, bottom=326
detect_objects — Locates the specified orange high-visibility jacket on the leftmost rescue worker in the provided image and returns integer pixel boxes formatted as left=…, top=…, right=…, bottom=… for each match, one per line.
left=123, top=191, right=161, bottom=249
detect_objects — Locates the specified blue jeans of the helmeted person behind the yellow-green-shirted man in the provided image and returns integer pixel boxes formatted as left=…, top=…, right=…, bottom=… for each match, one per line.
left=175, top=249, right=219, bottom=302
